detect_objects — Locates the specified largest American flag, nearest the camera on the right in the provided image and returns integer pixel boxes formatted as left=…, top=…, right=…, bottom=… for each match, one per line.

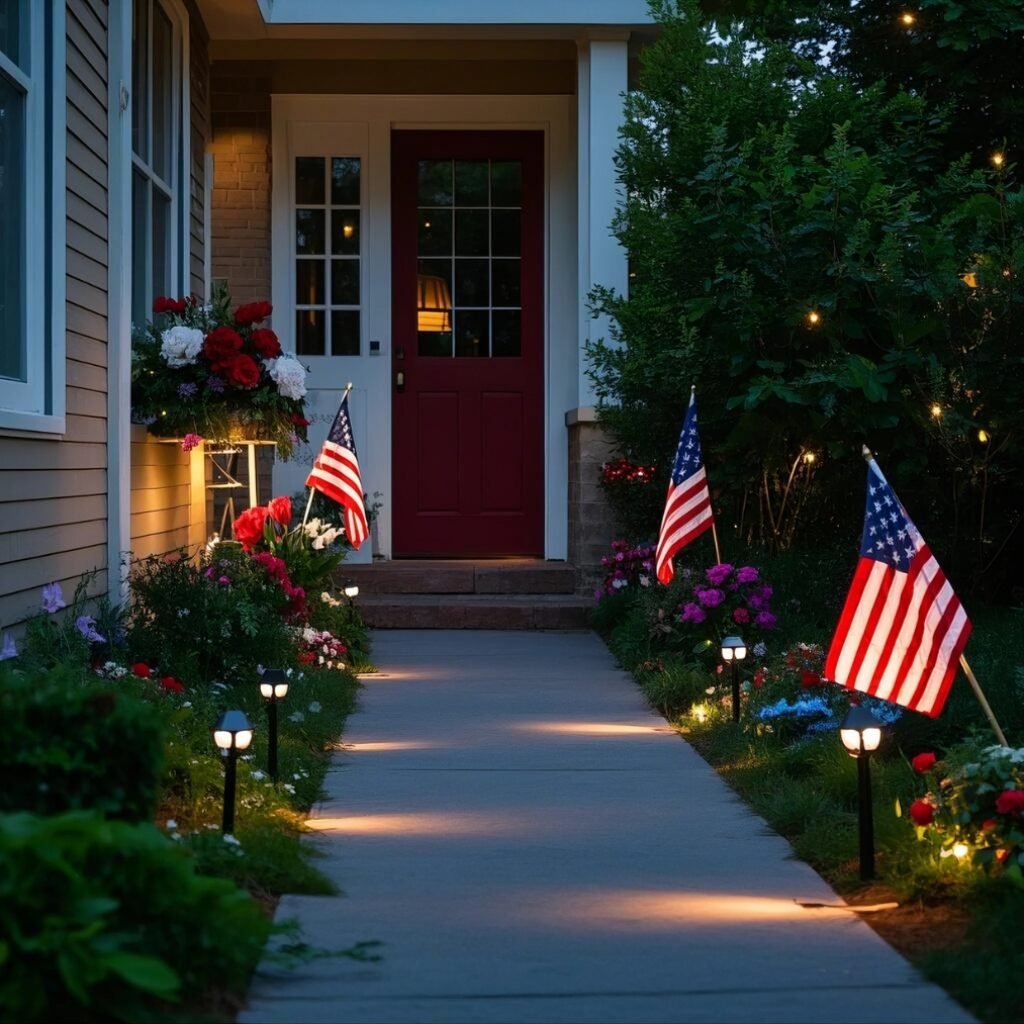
left=825, top=459, right=971, bottom=718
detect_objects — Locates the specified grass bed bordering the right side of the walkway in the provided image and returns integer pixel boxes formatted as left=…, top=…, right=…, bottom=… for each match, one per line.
left=595, top=551, right=1024, bottom=1024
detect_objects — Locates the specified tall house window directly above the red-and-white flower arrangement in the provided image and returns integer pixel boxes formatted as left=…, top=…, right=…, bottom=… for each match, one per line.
left=131, top=0, right=188, bottom=324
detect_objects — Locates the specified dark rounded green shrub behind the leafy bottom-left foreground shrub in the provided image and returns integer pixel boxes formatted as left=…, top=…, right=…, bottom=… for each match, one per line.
left=0, top=665, right=165, bottom=821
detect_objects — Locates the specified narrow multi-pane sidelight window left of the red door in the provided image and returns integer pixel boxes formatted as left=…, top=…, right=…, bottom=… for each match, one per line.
left=293, top=157, right=361, bottom=355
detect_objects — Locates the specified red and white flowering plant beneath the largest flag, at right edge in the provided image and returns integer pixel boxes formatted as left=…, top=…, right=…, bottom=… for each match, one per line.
left=907, top=743, right=1024, bottom=887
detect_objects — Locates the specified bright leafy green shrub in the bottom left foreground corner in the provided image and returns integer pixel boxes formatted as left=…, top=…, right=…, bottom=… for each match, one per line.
left=0, top=812, right=271, bottom=1024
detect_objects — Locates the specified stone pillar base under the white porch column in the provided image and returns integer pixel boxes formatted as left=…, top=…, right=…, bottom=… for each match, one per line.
left=565, top=409, right=615, bottom=595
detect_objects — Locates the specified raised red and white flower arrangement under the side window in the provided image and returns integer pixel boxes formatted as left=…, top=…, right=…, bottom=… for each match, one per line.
left=132, top=284, right=309, bottom=458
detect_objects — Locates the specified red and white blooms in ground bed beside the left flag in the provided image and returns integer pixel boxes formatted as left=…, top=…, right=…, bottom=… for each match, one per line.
left=232, top=497, right=345, bottom=608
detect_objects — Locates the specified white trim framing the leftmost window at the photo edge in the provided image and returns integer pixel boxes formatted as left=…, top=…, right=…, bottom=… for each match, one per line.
left=0, top=0, right=67, bottom=434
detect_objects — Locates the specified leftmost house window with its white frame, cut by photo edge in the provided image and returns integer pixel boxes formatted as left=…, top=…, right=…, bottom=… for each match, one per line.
left=0, top=0, right=65, bottom=430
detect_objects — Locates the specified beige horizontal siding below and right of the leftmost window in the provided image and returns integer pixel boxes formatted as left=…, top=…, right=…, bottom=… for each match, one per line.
left=0, top=0, right=108, bottom=629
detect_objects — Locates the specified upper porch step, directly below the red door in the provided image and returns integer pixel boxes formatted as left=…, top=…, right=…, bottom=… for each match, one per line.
left=338, top=558, right=575, bottom=595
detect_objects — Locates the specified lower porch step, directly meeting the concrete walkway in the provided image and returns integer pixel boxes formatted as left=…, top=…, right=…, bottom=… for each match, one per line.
left=356, top=583, right=594, bottom=630
